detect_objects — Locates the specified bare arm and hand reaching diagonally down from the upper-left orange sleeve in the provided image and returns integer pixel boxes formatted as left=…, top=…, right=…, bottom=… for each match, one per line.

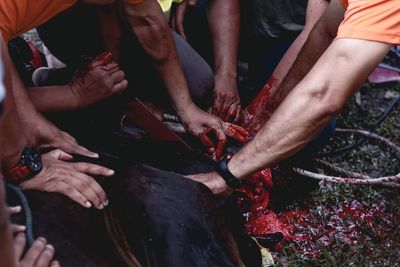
left=123, top=0, right=226, bottom=151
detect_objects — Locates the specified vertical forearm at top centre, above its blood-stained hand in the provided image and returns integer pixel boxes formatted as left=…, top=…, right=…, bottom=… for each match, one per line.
left=208, top=0, right=240, bottom=79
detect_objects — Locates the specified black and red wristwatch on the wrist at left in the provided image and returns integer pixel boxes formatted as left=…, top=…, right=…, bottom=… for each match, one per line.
left=6, top=147, right=43, bottom=183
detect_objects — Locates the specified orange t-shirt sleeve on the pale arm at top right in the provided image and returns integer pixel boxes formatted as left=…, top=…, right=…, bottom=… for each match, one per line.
left=336, top=0, right=400, bottom=45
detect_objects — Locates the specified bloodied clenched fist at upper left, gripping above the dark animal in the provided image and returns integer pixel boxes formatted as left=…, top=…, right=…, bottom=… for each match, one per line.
left=69, top=53, right=128, bottom=108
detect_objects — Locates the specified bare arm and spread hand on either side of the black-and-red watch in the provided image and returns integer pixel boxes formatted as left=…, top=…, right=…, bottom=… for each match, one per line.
left=0, top=34, right=114, bottom=209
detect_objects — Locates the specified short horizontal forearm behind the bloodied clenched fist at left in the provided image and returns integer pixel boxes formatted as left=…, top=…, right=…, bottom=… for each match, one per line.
left=28, top=84, right=78, bottom=112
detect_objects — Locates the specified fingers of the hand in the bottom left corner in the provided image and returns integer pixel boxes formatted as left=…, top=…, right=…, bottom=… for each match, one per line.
left=14, top=236, right=60, bottom=267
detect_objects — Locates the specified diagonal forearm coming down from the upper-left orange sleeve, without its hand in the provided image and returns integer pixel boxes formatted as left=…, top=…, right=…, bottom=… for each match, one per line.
left=125, top=0, right=193, bottom=113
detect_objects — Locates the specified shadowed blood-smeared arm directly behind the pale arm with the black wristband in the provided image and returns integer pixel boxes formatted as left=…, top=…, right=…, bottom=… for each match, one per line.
left=245, top=1, right=344, bottom=133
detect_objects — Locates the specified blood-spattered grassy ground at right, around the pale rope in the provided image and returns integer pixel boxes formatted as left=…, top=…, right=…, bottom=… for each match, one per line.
left=274, top=84, right=400, bottom=266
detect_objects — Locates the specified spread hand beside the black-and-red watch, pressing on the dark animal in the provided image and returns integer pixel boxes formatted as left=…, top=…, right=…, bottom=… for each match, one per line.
left=20, top=149, right=114, bottom=209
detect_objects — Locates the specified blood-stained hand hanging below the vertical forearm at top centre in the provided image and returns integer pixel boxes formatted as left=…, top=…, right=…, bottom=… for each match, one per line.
left=212, top=77, right=242, bottom=122
